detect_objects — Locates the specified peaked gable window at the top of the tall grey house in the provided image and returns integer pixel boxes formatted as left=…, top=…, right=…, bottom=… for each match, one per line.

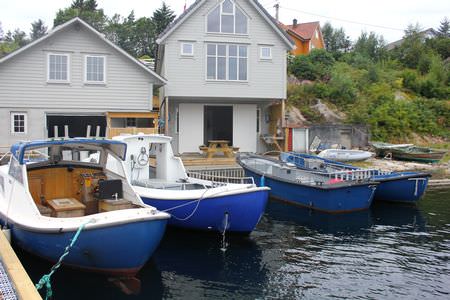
left=206, top=0, right=248, bottom=34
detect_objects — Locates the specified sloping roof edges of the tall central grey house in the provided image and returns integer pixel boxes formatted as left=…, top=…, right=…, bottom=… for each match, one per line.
left=156, top=0, right=295, bottom=49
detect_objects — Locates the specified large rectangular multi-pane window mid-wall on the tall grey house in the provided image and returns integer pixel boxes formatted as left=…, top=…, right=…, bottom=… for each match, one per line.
left=206, top=44, right=248, bottom=81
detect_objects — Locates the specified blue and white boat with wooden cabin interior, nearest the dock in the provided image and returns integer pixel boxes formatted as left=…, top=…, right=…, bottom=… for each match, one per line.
left=0, top=138, right=170, bottom=277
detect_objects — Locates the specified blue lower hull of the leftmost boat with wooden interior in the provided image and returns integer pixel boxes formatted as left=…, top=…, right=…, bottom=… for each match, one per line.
left=11, top=219, right=167, bottom=277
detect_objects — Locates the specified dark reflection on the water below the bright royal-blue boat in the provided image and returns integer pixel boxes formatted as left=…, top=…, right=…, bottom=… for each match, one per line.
left=154, top=229, right=268, bottom=299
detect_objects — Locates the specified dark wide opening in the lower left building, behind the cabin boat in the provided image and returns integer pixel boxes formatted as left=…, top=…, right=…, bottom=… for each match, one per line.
left=47, top=115, right=106, bottom=138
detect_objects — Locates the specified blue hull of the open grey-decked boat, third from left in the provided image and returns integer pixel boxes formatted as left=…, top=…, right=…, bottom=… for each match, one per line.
left=244, top=167, right=376, bottom=213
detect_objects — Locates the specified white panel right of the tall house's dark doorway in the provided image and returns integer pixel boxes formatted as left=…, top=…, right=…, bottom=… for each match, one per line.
left=233, top=104, right=257, bottom=152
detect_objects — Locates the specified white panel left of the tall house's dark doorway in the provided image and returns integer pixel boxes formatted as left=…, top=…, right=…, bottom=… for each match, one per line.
left=178, top=103, right=203, bottom=153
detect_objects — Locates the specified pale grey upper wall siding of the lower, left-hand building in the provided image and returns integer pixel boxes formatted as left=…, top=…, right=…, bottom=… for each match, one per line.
left=0, top=26, right=153, bottom=111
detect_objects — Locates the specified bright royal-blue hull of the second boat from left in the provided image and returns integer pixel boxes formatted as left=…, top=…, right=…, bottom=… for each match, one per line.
left=141, top=189, right=269, bottom=233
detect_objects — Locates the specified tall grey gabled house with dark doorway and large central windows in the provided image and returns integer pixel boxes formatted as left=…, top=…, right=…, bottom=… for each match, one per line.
left=157, top=0, right=294, bottom=153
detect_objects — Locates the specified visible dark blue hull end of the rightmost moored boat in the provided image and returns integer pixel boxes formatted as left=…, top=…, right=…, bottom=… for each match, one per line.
left=372, top=172, right=430, bottom=203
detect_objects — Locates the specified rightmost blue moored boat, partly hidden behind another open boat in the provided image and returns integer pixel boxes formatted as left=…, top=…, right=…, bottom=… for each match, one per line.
left=280, top=152, right=431, bottom=203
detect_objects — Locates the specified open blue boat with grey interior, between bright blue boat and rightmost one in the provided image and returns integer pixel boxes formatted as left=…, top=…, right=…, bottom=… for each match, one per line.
left=238, top=155, right=378, bottom=213
